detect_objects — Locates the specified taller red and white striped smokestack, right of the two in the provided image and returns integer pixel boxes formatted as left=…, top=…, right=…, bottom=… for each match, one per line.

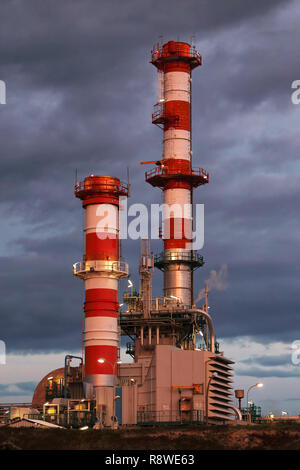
left=146, top=41, right=209, bottom=307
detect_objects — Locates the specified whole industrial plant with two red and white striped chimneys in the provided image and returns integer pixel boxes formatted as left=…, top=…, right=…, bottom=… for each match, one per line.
left=27, top=41, right=236, bottom=427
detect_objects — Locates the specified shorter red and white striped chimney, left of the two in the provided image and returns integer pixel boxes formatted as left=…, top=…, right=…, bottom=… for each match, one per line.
left=73, top=175, right=128, bottom=414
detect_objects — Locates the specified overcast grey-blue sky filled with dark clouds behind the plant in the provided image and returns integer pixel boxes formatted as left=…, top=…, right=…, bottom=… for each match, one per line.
left=0, top=0, right=300, bottom=414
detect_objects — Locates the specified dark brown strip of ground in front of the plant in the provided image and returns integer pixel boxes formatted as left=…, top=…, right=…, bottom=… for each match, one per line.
left=0, top=422, right=300, bottom=450
